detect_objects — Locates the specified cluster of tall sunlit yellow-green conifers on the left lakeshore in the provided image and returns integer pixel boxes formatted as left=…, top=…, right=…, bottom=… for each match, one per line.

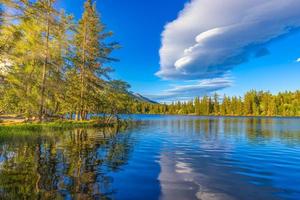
left=0, top=0, right=131, bottom=120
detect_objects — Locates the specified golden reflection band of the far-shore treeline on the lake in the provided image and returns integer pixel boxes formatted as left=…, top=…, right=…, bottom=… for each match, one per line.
left=135, top=115, right=300, bottom=142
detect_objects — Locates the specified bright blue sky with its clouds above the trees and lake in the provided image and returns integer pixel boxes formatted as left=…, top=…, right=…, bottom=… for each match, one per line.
left=60, top=0, right=300, bottom=101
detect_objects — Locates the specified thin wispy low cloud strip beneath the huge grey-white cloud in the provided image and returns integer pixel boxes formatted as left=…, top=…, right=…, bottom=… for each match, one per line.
left=147, top=77, right=232, bottom=101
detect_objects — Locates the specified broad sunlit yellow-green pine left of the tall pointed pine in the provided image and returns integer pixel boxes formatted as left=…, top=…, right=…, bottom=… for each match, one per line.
left=0, top=0, right=72, bottom=120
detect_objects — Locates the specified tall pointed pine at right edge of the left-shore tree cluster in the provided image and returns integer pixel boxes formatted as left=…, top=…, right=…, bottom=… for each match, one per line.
left=74, top=0, right=116, bottom=120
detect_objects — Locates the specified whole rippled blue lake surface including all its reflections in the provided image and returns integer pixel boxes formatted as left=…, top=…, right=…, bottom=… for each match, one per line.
left=0, top=115, right=300, bottom=200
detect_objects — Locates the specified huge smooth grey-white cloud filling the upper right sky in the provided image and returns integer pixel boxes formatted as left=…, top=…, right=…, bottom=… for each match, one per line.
left=157, top=0, right=300, bottom=80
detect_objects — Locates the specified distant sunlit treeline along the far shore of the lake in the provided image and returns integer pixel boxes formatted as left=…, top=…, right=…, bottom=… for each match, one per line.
left=131, top=90, right=300, bottom=116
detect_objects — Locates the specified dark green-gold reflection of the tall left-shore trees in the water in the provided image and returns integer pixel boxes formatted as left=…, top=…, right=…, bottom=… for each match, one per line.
left=0, top=127, right=133, bottom=199
